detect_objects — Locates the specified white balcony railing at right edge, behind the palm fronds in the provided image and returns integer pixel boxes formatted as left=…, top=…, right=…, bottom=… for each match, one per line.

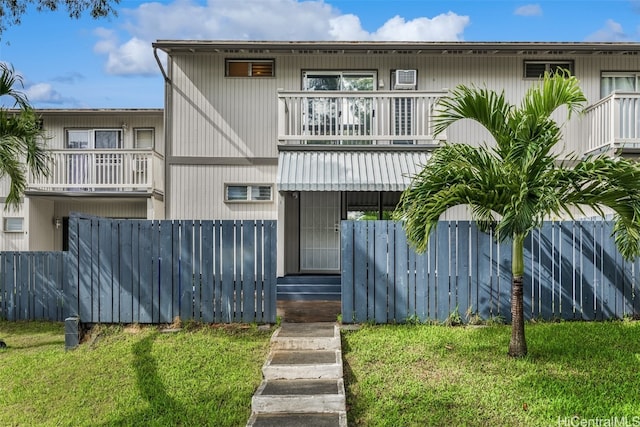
left=583, top=92, right=640, bottom=154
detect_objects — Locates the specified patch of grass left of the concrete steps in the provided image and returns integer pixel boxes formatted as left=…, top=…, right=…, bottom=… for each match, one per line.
left=0, top=322, right=272, bottom=426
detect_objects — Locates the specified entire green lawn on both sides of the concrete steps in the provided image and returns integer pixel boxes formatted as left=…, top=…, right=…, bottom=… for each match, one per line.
left=0, top=321, right=640, bottom=427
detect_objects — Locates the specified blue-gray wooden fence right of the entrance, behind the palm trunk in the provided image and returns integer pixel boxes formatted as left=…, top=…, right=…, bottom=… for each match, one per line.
left=342, top=221, right=640, bottom=323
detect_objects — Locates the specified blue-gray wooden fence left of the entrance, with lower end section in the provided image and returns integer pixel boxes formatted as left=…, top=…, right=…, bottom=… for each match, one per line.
left=0, top=216, right=276, bottom=323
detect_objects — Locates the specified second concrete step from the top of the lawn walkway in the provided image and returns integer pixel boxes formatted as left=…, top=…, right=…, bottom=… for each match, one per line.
left=262, top=350, right=342, bottom=380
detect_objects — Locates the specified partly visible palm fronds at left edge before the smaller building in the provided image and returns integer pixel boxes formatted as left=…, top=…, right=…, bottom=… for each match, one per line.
left=0, top=63, right=49, bottom=209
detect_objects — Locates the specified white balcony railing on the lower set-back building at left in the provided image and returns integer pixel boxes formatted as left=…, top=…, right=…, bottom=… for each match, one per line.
left=29, top=149, right=162, bottom=192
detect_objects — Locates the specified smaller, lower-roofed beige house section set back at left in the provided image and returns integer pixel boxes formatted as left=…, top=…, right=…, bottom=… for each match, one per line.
left=0, top=109, right=164, bottom=251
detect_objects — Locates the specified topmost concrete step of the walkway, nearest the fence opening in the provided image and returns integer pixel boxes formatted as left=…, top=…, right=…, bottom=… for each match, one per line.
left=271, top=323, right=341, bottom=350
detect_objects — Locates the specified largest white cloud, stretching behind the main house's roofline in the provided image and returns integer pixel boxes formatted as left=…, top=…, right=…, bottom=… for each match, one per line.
left=94, top=0, right=470, bottom=75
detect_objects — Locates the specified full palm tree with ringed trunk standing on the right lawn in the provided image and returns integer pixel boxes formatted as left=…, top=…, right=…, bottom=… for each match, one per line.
left=396, top=72, right=640, bottom=357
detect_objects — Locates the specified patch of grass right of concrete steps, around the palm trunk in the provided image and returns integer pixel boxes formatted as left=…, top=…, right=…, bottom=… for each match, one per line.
left=342, top=321, right=640, bottom=426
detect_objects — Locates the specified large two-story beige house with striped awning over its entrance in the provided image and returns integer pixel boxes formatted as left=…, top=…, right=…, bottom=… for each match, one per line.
left=153, top=40, right=640, bottom=276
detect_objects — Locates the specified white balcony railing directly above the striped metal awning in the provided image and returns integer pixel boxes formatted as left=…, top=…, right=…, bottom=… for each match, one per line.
left=278, top=91, right=446, bottom=145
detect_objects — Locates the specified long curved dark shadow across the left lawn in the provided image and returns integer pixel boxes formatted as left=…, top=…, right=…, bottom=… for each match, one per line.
left=96, top=333, right=189, bottom=426
